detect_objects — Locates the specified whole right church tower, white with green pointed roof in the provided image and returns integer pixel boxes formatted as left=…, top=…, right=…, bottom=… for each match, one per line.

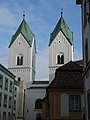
left=49, top=12, right=73, bottom=82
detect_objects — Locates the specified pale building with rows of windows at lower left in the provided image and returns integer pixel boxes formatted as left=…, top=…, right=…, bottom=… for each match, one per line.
left=0, top=64, right=26, bottom=120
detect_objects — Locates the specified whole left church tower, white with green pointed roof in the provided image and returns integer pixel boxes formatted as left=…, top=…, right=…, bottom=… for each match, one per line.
left=8, top=15, right=36, bottom=84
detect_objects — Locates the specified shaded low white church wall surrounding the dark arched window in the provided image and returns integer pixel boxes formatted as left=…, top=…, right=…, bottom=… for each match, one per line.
left=26, top=88, right=46, bottom=120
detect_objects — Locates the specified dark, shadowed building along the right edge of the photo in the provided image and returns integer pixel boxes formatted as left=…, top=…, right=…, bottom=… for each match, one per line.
left=76, top=0, right=90, bottom=120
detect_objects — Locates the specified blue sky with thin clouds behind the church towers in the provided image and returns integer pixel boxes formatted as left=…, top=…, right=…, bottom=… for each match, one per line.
left=0, top=0, right=82, bottom=80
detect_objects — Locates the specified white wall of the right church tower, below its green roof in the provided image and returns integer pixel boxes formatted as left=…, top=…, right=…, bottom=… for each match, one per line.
left=49, top=31, right=73, bottom=82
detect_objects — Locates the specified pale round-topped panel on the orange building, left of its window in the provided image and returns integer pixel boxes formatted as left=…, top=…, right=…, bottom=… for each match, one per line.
left=61, top=93, right=69, bottom=117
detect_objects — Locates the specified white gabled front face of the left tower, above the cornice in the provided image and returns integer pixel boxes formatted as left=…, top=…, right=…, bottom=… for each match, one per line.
left=9, top=34, right=31, bottom=68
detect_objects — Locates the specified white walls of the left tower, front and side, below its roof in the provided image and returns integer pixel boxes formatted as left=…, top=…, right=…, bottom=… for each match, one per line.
left=8, top=33, right=35, bottom=83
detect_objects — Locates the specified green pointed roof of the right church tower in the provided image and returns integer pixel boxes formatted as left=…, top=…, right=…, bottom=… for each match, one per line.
left=49, top=15, right=73, bottom=46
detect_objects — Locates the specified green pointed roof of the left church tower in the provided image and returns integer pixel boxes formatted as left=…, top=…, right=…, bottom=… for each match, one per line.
left=9, top=19, right=34, bottom=47
